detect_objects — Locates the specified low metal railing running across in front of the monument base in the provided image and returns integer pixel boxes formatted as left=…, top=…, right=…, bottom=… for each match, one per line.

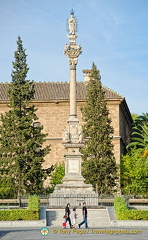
left=0, top=194, right=148, bottom=208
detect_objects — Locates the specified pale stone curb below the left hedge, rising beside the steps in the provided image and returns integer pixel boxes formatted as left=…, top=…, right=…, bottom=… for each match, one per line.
left=0, top=207, right=46, bottom=228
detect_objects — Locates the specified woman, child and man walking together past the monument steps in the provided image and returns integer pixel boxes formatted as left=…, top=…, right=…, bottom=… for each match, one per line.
left=63, top=202, right=88, bottom=228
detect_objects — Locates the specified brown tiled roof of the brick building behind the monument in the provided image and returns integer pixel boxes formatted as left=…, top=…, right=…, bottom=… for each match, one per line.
left=0, top=82, right=123, bottom=101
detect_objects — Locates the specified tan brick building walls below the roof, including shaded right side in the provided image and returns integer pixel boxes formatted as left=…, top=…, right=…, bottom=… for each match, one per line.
left=0, top=99, right=131, bottom=180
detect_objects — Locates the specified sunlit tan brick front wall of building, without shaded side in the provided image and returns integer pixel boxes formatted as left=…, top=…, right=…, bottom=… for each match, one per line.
left=35, top=100, right=125, bottom=167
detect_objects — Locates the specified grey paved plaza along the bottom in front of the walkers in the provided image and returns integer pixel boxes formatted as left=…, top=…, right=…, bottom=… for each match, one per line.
left=0, top=227, right=148, bottom=240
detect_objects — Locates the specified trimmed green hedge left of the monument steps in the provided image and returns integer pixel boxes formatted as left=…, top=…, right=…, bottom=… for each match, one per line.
left=0, top=196, right=40, bottom=221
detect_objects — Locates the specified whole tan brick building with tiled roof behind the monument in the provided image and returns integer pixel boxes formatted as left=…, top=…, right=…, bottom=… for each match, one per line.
left=0, top=81, right=132, bottom=177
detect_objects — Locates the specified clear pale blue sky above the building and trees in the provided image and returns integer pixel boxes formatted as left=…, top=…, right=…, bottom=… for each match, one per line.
left=0, top=0, right=148, bottom=114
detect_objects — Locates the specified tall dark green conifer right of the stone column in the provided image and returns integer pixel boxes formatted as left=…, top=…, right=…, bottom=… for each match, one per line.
left=81, top=63, right=117, bottom=194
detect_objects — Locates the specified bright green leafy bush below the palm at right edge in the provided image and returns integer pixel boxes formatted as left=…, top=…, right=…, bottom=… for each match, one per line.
left=120, top=148, right=148, bottom=197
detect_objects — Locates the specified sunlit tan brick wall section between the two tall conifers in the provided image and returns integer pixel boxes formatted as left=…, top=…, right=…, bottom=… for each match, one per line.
left=35, top=102, right=84, bottom=168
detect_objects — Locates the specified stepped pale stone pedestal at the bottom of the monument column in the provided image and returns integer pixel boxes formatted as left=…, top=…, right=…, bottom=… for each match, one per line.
left=50, top=143, right=98, bottom=206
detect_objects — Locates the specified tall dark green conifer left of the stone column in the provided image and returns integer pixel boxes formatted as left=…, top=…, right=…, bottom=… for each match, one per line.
left=0, top=37, right=50, bottom=195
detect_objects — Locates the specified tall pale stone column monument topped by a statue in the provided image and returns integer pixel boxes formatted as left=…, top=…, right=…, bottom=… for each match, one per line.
left=50, top=10, right=98, bottom=206
